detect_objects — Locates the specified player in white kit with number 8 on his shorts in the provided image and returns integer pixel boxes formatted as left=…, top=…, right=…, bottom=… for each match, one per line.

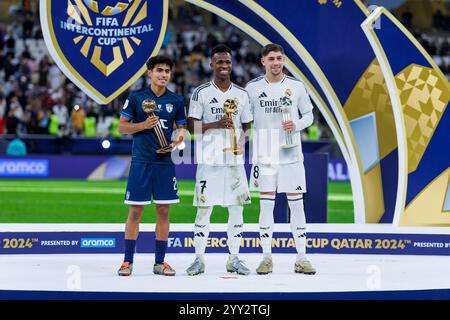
left=246, top=44, right=316, bottom=274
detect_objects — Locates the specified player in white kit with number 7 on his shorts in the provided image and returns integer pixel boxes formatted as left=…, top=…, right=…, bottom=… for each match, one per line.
left=186, top=45, right=253, bottom=275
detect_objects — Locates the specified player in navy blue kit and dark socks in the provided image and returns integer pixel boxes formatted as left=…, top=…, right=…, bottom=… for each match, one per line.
left=118, top=56, right=186, bottom=276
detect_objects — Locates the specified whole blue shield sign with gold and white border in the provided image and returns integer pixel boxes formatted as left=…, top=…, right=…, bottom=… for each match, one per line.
left=40, top=0, right=168, bottom=104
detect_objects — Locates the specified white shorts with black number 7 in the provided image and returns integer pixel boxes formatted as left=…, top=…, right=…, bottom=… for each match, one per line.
left=193, top=164, right=250, bottom=207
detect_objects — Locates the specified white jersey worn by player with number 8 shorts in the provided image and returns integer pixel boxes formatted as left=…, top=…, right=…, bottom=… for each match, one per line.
left=246, top=76, right=313, bottom=164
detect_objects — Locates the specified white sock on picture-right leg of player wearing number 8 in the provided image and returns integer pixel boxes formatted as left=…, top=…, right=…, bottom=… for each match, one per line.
left=287, top=194, right=306, bottom=255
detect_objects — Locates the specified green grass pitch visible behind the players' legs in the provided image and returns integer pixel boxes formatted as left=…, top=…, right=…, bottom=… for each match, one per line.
left=0, top=179, right=353, bottom=223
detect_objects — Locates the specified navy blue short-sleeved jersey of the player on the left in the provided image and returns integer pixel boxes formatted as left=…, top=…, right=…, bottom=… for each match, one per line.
left=120, top=88, right=186, bottom=164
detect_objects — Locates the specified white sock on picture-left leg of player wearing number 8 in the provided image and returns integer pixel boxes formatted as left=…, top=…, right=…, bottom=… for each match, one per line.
left=259, top=194, right=275, bottom=256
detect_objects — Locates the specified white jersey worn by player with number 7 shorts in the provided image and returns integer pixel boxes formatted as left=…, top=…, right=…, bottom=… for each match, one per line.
left=189, top=81, right=253, bottom=165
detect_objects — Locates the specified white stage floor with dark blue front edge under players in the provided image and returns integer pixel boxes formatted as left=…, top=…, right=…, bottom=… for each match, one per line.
left=0, top=253, right=450, bottom=300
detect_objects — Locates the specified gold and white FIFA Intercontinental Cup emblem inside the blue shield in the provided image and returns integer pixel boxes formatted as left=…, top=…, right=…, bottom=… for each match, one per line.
left=65, top=0, right=153, bottom=76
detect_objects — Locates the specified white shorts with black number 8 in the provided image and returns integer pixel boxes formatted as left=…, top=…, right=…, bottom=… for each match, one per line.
left=250, top=161, right=306, bottom=193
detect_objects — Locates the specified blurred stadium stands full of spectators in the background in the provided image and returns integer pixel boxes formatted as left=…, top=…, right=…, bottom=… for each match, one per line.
left=0, top=0, right=450, bottom=139
